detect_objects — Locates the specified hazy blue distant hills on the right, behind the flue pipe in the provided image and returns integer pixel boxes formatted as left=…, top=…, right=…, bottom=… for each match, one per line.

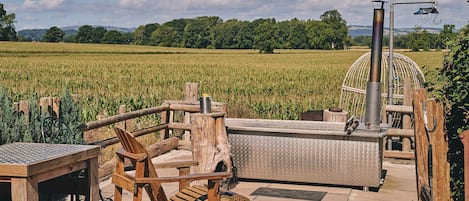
left=348, top=25, right=442, bottom=37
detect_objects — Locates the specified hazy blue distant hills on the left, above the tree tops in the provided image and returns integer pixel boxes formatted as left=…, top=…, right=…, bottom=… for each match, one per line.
left=18, top=26, right=135, bottom=41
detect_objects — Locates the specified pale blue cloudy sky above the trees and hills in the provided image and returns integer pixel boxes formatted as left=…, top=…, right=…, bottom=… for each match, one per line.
left=0, top=0, right=469, bottom=31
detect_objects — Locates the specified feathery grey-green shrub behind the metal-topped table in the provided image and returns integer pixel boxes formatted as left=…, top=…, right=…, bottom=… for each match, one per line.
left=0, top=89, right=83, bottom=144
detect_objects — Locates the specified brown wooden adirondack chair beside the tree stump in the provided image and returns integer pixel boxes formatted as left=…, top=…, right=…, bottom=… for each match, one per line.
left=112, top=127, right=246, bottom=201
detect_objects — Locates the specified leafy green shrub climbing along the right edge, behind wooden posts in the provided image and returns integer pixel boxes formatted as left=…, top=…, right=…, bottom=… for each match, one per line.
left=429, top=25, right=469, bottom=201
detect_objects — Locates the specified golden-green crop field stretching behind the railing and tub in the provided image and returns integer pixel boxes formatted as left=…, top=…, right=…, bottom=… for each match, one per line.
left=0, top=42, right=444, bottom=121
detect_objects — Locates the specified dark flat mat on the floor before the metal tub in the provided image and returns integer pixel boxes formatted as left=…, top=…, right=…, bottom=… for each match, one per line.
left=251, top=187, right=326, bottom=201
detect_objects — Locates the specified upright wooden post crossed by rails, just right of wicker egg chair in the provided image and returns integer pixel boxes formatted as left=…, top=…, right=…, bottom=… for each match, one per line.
left=402, top=78, right=413, bottom=152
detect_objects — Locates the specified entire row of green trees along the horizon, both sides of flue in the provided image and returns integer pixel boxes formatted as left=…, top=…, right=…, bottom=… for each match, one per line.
left=0, top=3, right=456, bottom=53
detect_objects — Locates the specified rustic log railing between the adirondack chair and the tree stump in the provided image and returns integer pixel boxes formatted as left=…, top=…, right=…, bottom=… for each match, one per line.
left=79, top=83, right=226, bottom=177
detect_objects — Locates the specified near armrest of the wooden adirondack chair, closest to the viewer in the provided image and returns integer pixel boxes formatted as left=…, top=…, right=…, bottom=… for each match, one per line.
left=135, top=172, right=232, bottom=184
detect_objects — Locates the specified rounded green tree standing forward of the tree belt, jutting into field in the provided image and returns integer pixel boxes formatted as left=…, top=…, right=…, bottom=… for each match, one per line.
left=254, top=21, right=277, bottom=54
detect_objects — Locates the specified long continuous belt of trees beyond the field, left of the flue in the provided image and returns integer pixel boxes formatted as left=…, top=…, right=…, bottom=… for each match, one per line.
left=33, top=10, right=351, bottom=53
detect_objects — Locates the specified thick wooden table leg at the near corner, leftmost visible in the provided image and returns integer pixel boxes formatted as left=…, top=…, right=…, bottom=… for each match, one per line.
left=11, top=177, right=39, bottom=201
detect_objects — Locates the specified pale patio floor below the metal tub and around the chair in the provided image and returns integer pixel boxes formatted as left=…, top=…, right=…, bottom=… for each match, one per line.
left=100, top=151, right=417, bottom=201
